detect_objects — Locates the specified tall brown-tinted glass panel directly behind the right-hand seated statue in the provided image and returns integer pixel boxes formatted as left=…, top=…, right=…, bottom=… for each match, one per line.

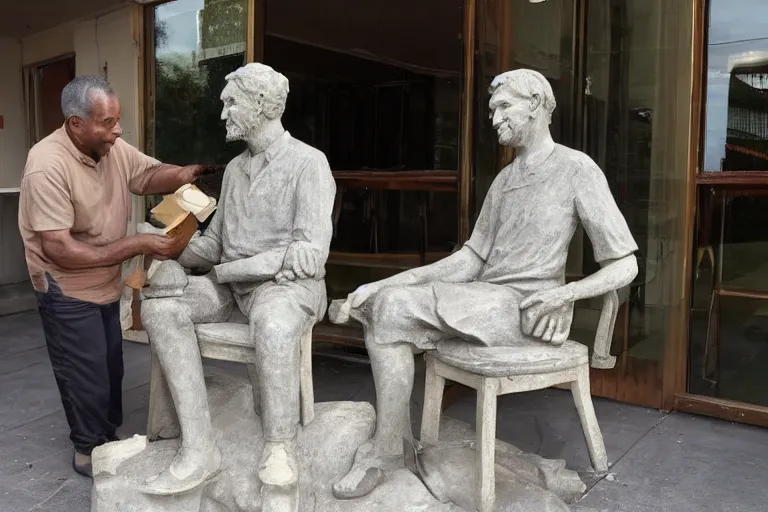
left=475, top=0, right=693, bottom=407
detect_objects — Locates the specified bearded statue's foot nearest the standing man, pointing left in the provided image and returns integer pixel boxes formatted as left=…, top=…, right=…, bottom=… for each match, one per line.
left=143, top=446, right=221, bottom=495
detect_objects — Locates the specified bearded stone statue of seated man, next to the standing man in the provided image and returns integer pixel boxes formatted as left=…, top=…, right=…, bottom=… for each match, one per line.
left=141, top=63, right=336, bottom=494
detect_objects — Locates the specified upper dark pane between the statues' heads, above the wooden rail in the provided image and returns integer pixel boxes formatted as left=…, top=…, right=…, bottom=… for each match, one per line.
left=264, top=0, right=463, bottom=171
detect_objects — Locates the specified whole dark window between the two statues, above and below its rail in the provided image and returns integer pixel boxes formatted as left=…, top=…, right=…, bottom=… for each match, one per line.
left=263, top=0, right=464, bottom=298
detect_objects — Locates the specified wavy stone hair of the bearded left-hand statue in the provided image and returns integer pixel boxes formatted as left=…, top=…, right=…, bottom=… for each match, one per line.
left=225, top=62, right=289, bottom=119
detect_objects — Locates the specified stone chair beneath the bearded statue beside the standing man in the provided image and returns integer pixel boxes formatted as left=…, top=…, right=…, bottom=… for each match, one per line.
left=147, top=322, right=315, bottom=441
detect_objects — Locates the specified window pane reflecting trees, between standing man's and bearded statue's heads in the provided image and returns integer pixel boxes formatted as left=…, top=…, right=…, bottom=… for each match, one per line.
left=148, top=0, right=248, bottom=172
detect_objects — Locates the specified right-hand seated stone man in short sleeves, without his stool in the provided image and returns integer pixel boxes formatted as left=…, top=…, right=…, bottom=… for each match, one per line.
left=331, top=70, right=637, bottom=498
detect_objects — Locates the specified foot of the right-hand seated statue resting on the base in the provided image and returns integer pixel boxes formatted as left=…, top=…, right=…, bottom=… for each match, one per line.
left=333, top=442, right=404, bottom=500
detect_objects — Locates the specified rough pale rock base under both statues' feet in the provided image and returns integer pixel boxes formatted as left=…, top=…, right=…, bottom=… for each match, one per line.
left=91, top=376, right=584, bottom=512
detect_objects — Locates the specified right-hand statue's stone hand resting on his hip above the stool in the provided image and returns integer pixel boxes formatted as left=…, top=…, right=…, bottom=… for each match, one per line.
left=520, top=285, right=574, bottom=343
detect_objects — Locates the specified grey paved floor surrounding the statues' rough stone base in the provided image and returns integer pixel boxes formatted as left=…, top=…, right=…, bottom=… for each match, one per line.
left=0, top=313, right=768, bottom=512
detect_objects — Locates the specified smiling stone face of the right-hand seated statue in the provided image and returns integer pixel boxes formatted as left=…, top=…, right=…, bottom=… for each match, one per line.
left=489, top=85, right=533, bottom=147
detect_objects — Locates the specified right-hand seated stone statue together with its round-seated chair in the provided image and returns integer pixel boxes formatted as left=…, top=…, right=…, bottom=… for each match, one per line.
left=329, top=69, right=637, bottom=512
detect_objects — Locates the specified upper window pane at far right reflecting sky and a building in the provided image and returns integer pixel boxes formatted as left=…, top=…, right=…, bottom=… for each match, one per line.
left=703, top=0, right=768, bottom=171
